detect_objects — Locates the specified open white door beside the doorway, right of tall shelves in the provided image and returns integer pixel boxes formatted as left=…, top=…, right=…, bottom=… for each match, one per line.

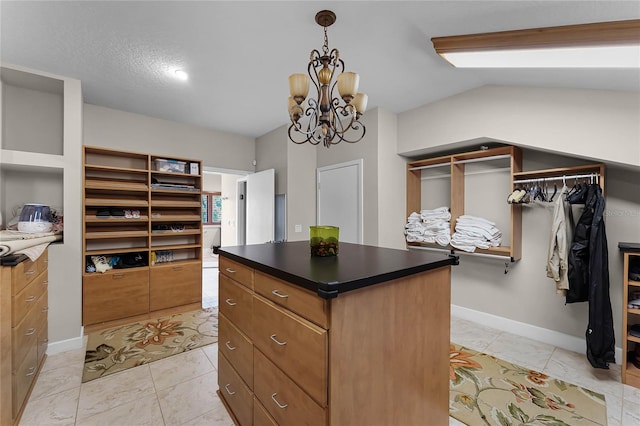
left=244, top=169, right=276, bottom=244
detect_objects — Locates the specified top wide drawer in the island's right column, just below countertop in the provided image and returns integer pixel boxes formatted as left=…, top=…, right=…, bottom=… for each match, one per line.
left=254, top=271, right=328, bottom=328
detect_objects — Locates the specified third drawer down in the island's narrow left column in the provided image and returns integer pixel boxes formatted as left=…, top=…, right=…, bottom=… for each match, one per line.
left=218, top=314, right=253, bottom=388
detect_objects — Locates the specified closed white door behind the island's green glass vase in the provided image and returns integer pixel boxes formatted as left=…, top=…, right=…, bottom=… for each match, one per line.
left=317, top=160, right=363, bottom=244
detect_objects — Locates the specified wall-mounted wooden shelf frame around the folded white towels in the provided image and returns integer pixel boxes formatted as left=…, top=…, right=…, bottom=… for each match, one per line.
left=407, top=146, right=522, bottom=261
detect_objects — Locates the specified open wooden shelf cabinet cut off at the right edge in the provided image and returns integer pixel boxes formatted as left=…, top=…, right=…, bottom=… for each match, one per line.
left=621, top=243, right=640, bottom=389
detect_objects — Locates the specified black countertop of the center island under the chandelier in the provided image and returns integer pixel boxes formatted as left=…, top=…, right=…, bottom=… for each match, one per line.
left=219, top=241, right=458, bottom=299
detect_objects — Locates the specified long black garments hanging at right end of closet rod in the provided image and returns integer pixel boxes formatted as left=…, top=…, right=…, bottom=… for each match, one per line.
left=566, top=184, right=615, bottom=369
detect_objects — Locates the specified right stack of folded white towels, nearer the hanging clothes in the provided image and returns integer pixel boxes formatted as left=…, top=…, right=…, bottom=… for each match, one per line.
left=451, top=215, right=502, bottom=252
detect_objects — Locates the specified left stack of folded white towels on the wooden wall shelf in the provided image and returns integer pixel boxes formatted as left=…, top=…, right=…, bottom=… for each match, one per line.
left=405, top=207, right=451, bottom=246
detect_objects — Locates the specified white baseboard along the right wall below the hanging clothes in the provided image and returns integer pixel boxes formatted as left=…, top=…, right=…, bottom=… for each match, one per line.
left=451, top=305, right=622, bottom=362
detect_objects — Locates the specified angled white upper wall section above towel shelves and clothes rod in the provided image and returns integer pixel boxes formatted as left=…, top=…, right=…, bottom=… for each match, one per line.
left=398, top=86, right=640, bottom=166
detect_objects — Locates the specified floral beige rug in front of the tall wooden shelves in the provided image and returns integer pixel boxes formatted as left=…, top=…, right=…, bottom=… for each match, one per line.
left=82, top=308, right=218, bottom=383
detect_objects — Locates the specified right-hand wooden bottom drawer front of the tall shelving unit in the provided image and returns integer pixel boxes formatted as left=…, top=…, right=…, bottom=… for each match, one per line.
left=149, top=262, right=202, bottom=311
